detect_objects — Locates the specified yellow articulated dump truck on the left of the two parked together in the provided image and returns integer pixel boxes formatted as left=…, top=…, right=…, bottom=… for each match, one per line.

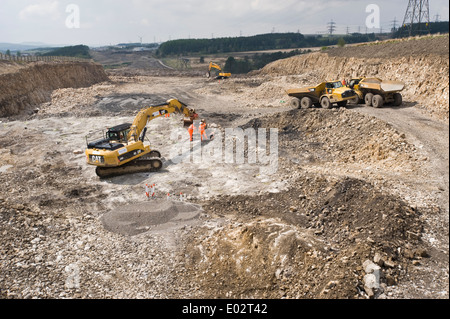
left=287, top=81, right=357, bottom=109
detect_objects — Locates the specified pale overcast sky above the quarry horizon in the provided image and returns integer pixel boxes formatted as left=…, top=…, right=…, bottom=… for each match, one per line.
left=0, top=0, right=449, bottom=46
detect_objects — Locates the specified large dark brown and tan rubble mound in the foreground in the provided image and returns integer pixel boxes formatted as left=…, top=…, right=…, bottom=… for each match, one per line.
left=184, top=175, right=427, bottom=299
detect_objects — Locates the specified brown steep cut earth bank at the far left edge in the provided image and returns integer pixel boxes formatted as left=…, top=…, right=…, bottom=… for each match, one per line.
left=0, top=62, right=108, bottom=117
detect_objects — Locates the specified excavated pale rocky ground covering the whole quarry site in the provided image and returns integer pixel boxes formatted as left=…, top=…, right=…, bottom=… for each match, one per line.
left=0, top=36, right=449, bottom=299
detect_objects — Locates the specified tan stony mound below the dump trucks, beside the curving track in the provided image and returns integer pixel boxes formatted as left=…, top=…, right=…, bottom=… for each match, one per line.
left=243, top=108, right=419, bottom=171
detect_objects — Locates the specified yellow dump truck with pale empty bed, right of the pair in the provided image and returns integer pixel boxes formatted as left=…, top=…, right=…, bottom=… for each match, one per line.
left=348, top=78, right=405, bottom=108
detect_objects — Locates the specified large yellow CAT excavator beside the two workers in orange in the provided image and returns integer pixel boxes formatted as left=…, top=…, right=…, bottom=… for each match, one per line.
left=86, top=99, right=196, bottom=178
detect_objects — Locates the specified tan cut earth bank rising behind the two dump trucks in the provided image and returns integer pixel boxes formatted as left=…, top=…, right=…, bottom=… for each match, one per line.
left=260, top=36, right=449, bottom=120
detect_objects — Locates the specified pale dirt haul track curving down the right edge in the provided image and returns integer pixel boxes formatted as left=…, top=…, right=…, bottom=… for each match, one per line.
left=354, top=102, right=449, bottom=298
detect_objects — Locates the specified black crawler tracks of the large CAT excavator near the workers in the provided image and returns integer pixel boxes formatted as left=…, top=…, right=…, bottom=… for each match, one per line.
left=95, top=157, right=163, bottom=179
